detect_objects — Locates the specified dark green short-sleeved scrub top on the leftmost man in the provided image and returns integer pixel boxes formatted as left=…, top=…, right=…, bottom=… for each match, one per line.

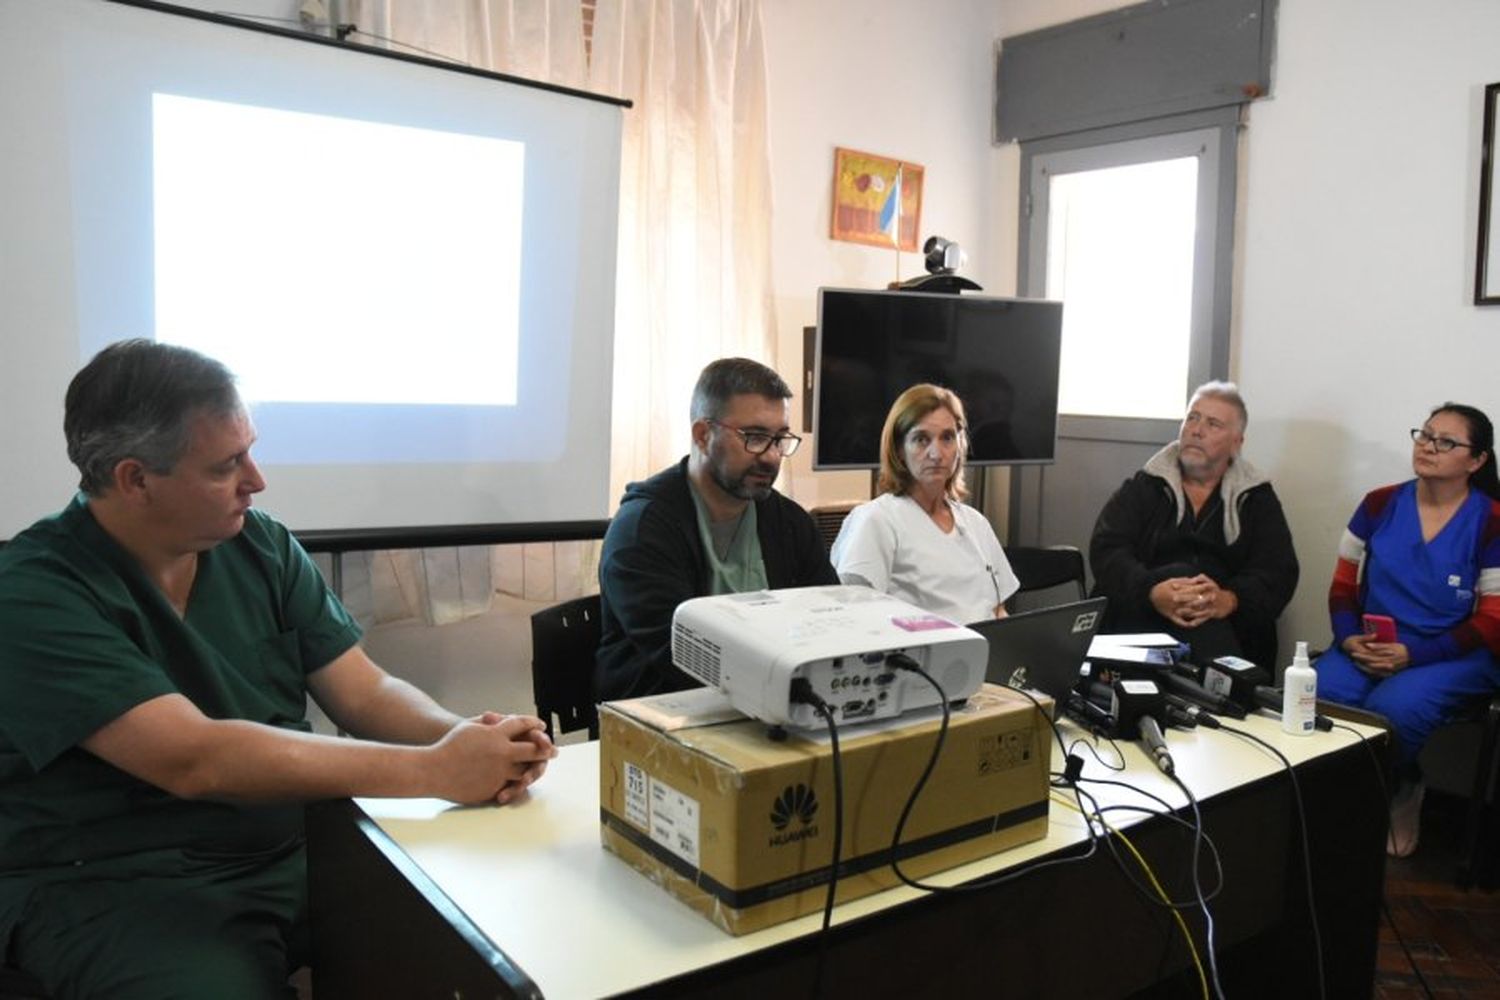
left=0, top=495, right=360, bottom=952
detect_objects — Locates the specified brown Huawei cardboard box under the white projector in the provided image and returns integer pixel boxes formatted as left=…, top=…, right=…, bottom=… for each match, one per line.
left=599, top=685, right=1052, bottom=934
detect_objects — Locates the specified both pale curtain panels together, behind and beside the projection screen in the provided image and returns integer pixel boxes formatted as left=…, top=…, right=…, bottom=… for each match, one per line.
left=328, top=0, right=777, bottom=624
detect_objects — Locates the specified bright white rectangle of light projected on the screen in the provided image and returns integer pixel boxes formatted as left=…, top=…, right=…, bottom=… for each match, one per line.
left=152, top=93, right=525, bottom=406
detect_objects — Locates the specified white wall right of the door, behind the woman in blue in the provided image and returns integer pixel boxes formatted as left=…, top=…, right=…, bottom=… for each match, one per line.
left=1236, top=0, right=1500, bottom=656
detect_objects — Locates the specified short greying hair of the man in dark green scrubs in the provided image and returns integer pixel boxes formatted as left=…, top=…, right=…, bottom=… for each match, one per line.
left=63, top=339, right=245, bottom=496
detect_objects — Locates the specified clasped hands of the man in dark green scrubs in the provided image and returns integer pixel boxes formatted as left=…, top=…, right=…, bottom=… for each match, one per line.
left=432, top=712, right=558, bottom=805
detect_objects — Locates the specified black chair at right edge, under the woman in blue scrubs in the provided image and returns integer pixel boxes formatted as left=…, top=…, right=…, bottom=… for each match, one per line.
left=1419, top=696, right=1500, bottom=889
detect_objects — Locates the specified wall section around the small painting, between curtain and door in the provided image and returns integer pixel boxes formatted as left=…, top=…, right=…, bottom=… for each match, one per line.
left=764, top=0, right=1016, bottom=505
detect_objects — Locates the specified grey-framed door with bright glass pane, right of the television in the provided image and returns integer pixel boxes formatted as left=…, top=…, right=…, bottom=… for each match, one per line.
left=1010, top=108, right=1238, bottom=547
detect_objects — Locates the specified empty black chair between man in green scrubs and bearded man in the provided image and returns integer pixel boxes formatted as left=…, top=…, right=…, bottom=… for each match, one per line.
left=531, top=594, right=599, bottom=739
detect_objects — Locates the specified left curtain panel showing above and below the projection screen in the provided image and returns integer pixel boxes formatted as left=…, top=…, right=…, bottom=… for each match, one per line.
left=342, top=0, right=599, bottom=625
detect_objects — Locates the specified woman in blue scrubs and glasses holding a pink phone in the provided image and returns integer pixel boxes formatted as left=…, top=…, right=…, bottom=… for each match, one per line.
left=1317, top=403, right=1500, bottom=858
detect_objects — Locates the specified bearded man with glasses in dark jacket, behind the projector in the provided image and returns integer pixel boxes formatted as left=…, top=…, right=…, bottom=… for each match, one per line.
left=596, top=358, right=839, bottom=702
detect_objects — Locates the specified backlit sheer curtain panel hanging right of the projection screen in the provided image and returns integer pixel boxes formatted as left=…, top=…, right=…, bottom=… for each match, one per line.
left=588, top=0, right=776, bottom=498
